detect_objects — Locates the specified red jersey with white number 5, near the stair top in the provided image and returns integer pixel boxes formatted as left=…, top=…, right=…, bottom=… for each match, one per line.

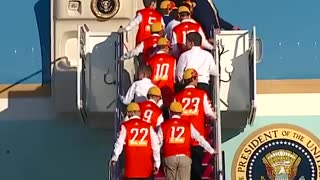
left=136, top=8, right=163, bottom=45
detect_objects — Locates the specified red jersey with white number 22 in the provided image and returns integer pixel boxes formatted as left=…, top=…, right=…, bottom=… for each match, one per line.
left=122, top=119, right=153, bottom=178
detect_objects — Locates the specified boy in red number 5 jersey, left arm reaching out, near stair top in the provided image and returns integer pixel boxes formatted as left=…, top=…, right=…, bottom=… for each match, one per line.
left=119, top=0, right=165, bottom=45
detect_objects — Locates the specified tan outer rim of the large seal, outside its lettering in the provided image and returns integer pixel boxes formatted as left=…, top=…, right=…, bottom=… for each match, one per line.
left=231, top=123, right=320, bottom=180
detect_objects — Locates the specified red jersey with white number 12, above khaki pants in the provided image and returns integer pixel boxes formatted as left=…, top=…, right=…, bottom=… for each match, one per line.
left=160, top=117, right=192, bottom=157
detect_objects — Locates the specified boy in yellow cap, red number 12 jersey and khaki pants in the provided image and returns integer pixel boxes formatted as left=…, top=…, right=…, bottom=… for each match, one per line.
left=158, top=102, right=215, bottom=180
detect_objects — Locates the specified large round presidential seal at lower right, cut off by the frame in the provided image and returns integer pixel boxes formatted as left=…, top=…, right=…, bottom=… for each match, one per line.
left=231, top=124, right=320, bottom=180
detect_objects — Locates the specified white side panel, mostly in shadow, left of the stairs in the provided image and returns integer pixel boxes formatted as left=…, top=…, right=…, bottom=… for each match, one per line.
left=77, top=25, right=118, bottom=122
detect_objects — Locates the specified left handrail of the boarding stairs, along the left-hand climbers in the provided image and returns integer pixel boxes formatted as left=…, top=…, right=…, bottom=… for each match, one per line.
left=109, top=26, right=124, bottom=180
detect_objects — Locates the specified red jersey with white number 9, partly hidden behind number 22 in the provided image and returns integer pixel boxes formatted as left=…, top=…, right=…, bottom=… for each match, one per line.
left=139, top=100, right=163, bottom=129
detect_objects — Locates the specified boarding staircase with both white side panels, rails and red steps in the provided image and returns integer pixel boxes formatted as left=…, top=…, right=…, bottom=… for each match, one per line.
left=77, top=25, right=261, bottom=180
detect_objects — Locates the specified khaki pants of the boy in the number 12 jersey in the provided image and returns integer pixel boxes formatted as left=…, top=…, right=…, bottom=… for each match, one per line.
left=164, top=156, right=192, bottom=180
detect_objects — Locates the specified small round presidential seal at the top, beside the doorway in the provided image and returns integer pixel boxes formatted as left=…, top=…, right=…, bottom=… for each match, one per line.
left=91, top=0, right=120, bottom=20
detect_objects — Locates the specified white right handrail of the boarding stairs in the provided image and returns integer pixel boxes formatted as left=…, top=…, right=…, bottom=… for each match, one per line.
left=211, top=28, right=224, bottom=180
